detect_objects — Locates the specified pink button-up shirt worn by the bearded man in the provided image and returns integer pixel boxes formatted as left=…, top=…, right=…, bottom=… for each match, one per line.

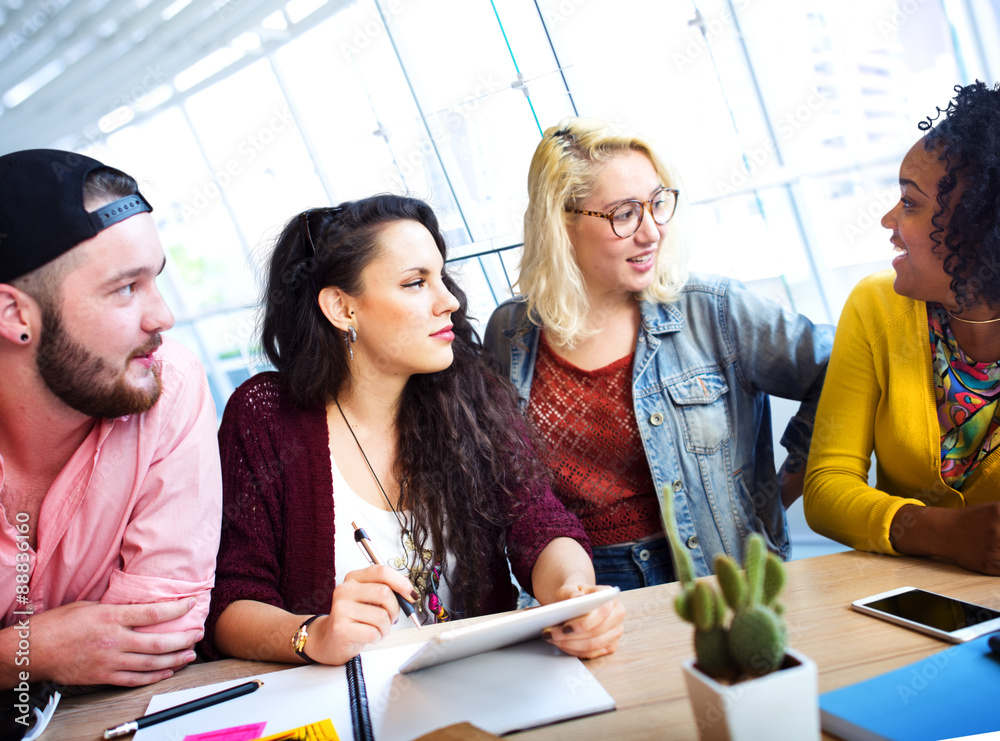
left=0, top=339, right=222, bottom=632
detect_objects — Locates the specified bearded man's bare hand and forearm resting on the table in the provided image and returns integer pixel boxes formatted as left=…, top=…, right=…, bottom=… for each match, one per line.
left=0, top=597, right=203, bottom=687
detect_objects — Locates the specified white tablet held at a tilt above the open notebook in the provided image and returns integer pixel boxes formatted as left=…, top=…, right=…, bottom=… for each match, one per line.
left=399, top=587, right=621, bottom=674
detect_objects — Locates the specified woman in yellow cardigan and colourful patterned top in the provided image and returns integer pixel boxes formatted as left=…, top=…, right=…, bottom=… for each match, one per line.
left=805, top=82, right=1000, bottom=574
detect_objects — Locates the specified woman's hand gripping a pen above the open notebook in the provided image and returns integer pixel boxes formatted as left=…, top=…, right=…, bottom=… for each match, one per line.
left=305, top=566, right=417, bottom=666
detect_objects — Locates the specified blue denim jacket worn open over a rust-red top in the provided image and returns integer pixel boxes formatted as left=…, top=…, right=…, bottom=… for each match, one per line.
left=484, top=275, right=833, bottom=576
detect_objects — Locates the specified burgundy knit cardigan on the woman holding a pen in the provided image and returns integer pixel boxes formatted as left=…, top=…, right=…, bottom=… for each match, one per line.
left=199, top=372, right=590, bottom=659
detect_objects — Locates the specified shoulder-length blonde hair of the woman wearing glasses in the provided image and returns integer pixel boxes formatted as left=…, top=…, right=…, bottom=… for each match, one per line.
left=517, top=118, right=688, bottom=347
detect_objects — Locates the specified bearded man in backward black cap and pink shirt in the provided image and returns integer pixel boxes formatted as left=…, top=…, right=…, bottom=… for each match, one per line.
left=0, top=150, right=222, bottom=689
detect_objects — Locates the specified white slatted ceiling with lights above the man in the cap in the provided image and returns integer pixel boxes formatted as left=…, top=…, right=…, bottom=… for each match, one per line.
left=0, top=0, right=349, bottom=154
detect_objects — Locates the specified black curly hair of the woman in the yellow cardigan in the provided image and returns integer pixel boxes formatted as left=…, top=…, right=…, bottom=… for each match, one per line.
left=918, top=80, right=1000, bottom=311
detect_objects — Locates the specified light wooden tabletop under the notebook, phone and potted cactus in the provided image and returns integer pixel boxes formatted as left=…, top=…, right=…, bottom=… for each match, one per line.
left=42, top=551, right=1000, bottom=741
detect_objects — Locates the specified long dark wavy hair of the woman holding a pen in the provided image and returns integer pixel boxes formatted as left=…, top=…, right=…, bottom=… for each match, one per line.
left=261, top=195, right=545, bottom=617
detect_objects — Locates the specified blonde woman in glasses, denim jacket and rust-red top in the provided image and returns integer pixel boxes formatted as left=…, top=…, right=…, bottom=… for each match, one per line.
left=485, top=118, right=832, bottom=589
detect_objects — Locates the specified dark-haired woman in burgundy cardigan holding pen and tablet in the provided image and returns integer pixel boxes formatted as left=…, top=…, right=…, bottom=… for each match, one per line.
left=202, top=195, right=624, bottom=664
